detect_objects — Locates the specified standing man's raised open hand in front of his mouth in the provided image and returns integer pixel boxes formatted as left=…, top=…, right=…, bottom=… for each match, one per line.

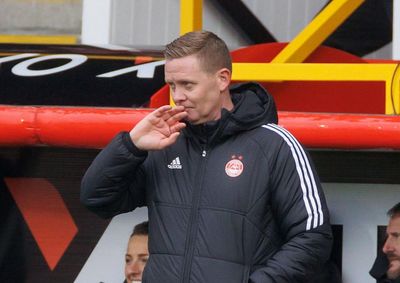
left=129, top=105, right=187, bottom=150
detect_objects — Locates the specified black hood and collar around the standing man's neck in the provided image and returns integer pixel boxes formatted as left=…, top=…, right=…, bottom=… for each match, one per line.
left=185, top=83, right=278, bottom=143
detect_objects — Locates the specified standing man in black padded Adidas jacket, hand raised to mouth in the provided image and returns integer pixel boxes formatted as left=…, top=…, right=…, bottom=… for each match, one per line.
left=81, top=31, right=332, bottom=283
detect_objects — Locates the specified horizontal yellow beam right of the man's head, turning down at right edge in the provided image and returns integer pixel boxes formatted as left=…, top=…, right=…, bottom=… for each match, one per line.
left=232, top=63, right=400, bottom=115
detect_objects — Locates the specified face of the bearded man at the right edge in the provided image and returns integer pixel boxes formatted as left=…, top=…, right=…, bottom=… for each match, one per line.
left=383, top=215, right=400, bottom=279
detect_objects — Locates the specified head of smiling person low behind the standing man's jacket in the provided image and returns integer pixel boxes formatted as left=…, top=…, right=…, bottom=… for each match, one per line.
left=125, top=221, right=149, bottom=283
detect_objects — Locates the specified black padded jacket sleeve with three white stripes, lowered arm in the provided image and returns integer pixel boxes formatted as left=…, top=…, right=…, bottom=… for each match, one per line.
left=249, top=126, right=332, bottom=283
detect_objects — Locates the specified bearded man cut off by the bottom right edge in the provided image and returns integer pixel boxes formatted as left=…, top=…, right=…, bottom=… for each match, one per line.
left=370, top=203, right=400, bottom=283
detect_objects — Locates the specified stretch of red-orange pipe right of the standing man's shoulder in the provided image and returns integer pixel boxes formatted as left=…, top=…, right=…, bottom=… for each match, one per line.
left=279, top=112, right=400, bottom=149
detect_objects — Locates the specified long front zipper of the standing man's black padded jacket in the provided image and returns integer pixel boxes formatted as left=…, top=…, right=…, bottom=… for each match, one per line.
left=182, top=149, right=207, bottom=283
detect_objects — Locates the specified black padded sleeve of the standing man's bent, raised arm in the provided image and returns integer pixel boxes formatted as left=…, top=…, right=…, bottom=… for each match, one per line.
left=80, top=132, right=147, bottom=218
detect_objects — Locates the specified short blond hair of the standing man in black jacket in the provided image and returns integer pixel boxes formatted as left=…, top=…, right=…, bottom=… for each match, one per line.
left=164, top=31, right=232, bottom=73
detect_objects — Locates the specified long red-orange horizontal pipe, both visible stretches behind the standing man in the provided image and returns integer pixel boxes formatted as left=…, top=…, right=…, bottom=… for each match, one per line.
left=0, top=106, right=400, bottom=149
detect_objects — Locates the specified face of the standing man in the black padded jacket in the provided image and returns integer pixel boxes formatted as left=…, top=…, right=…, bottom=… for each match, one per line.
left=165, top=55, right=226, bottom=124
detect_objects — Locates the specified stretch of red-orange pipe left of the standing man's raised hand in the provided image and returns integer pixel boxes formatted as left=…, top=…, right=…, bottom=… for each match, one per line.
left=0, top=106, right=151, bottom=148
